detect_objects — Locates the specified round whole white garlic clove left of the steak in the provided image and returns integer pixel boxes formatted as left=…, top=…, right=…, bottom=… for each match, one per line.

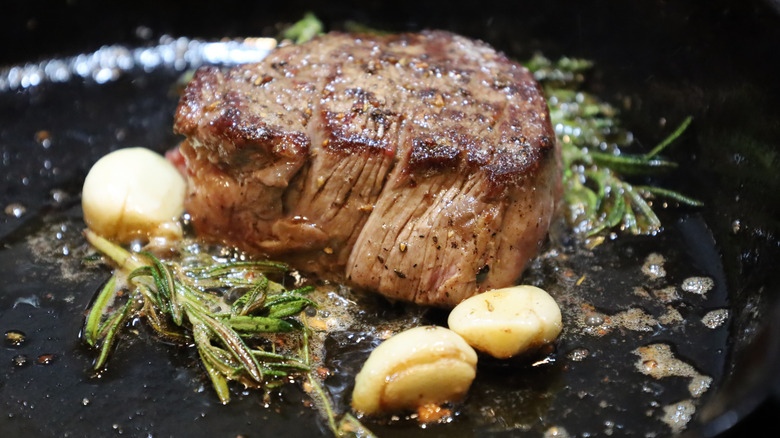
left=81, top=148, right=186, bottom=243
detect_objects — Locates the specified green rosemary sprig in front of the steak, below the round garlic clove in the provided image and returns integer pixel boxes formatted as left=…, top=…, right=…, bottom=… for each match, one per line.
left=83, top=230, right=315, bottom=403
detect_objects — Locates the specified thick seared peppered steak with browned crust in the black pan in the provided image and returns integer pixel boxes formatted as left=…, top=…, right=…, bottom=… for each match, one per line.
left=175, top=31, right=560, bottom=307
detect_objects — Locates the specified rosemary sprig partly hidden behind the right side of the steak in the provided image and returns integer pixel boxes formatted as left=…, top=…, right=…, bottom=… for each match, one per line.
left=526, top=55, right=701, bottom=237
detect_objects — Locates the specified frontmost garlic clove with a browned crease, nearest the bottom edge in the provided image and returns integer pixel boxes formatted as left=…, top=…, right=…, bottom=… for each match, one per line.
left=352, top=326, right=477, bottom=414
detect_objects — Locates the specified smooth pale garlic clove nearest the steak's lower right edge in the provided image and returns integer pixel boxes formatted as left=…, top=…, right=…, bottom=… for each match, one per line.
left=447, top=286, right=562, bottom=359
